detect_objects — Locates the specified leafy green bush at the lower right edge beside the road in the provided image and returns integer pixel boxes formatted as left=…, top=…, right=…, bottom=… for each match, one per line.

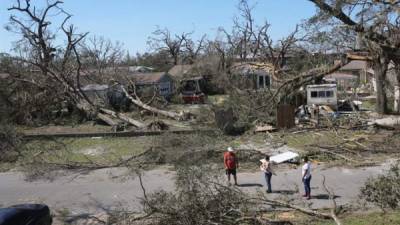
left=360, top=163, right=400, bottom=210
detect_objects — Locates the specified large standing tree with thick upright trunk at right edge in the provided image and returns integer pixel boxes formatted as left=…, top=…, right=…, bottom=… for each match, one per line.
left=309, top=0, right=400, bottom=114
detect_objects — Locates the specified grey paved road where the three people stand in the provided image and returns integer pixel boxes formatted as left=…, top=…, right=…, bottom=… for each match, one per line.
left=0, top=164, right=388, bottom=213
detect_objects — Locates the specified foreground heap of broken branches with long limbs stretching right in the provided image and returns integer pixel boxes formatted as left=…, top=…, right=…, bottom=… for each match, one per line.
left=110, top=166, right=340, bottom=225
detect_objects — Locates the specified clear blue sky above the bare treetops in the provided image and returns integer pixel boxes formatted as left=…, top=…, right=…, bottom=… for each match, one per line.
left=0, top=0, right=315, bottom=54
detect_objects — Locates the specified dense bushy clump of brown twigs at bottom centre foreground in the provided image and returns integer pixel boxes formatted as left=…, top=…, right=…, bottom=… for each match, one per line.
left=137, top=164, right=248, bottom=225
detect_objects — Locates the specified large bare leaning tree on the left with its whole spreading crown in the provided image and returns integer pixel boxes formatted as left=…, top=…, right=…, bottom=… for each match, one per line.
left=6, top=0, right=184, bottom=127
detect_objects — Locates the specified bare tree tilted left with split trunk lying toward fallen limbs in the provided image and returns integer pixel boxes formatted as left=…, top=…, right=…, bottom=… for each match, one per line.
left=7, top=0, right=152, bottom=128
